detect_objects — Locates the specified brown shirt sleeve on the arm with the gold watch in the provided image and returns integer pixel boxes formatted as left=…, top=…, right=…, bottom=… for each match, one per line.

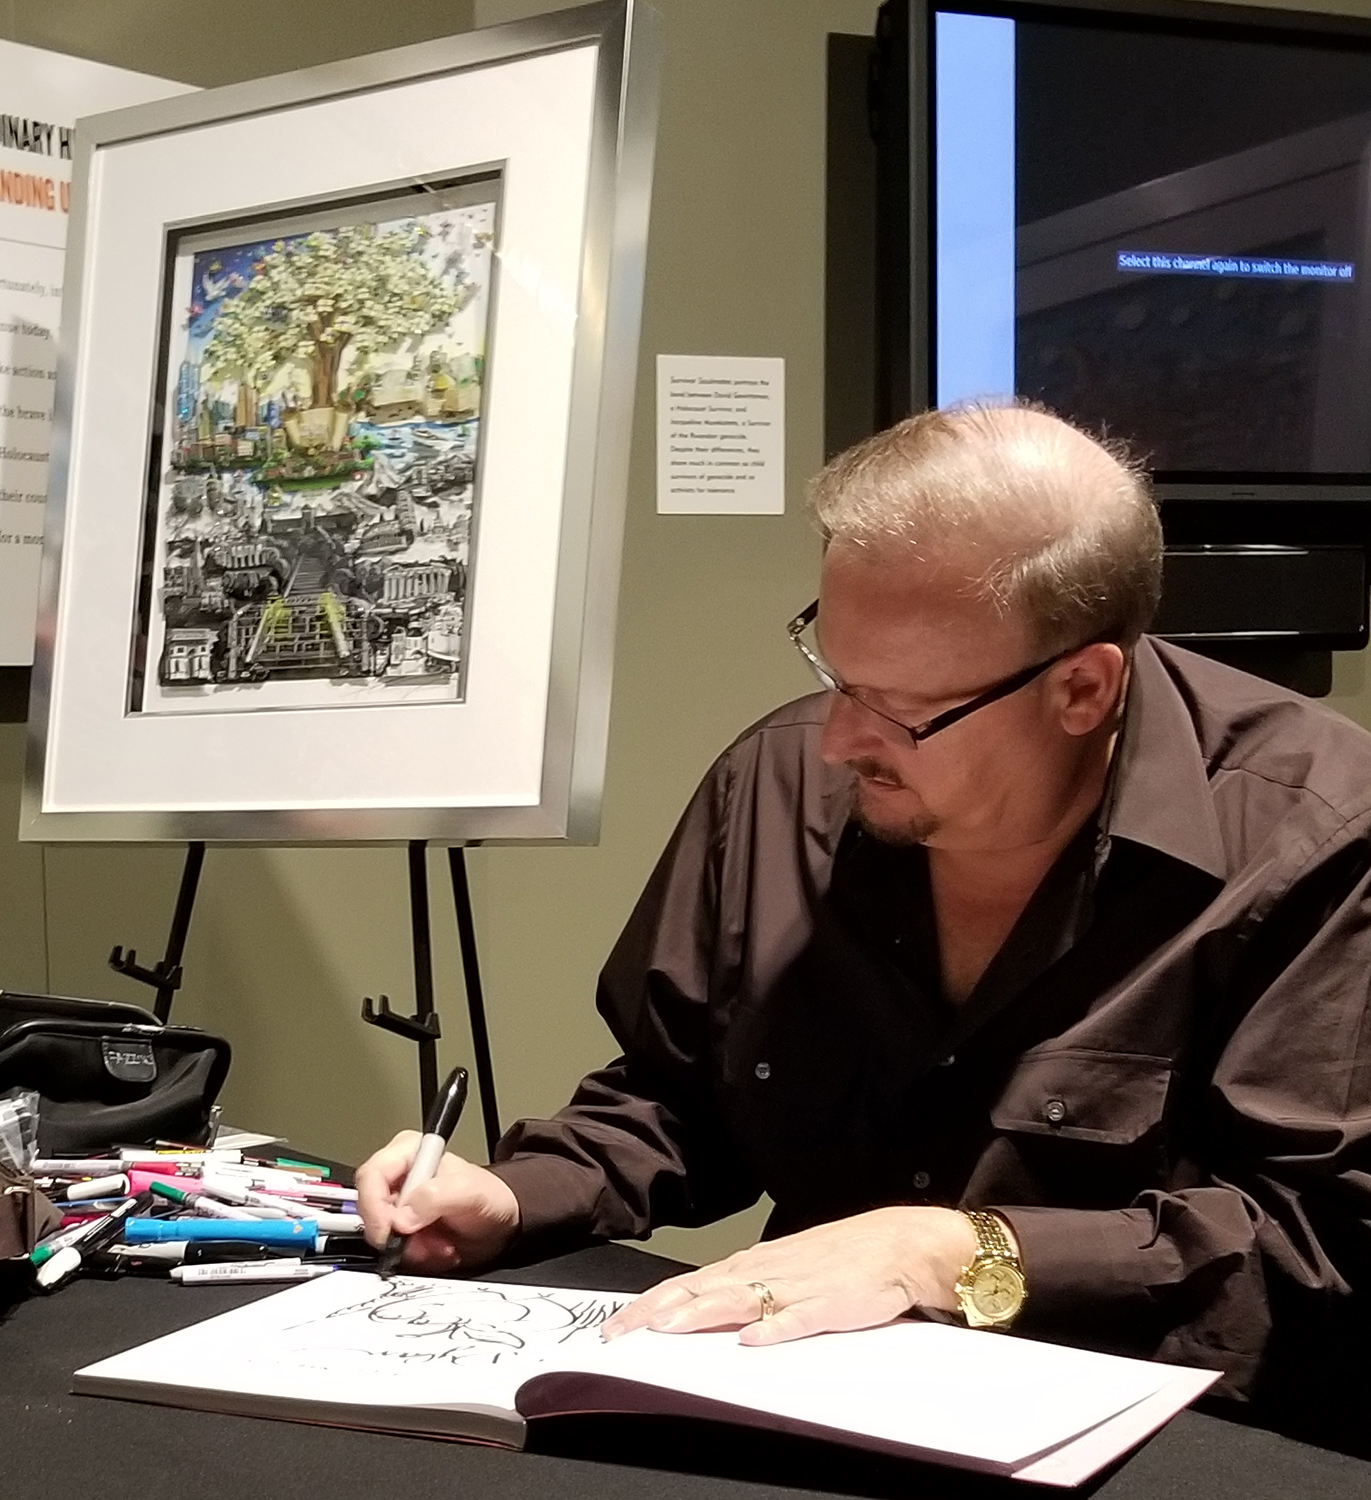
left=996, top=830, right=1371, bottom=1395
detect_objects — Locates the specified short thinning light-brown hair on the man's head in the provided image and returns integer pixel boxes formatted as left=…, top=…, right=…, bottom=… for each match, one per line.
left=810, top=404, right=1161, bottom=653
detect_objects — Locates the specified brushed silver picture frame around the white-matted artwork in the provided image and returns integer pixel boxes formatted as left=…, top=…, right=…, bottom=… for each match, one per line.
left=20, top=0, right=660, bottom=845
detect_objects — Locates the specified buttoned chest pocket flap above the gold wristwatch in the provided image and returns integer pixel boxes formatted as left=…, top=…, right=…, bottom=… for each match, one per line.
left=990, top=1047, right=1175, bottom=1146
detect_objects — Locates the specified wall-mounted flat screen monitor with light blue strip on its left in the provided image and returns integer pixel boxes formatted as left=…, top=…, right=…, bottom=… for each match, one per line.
left=882, top=0, right=1371, bottom=501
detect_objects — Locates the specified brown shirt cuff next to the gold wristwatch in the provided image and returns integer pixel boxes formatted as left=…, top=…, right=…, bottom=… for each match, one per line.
left=995, top=1205, right=1182, bottom=1322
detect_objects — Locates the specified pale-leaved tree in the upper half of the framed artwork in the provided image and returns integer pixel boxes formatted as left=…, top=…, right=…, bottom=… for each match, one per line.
left=195, top=222, right=479, bottom=435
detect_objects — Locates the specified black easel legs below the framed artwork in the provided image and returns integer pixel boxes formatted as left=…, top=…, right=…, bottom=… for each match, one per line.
left=110, top=839, right=500, bottom=1155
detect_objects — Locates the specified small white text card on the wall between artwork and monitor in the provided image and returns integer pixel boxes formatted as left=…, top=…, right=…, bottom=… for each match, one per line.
left=657, top=354, right=786, bottom=516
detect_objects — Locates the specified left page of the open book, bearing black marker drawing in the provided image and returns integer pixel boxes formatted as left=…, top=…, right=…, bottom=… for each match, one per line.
left=78, top=1271, right=632, bottom=1413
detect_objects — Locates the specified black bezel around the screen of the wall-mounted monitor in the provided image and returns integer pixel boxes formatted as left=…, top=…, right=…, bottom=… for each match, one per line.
left=872, top=0, right=1371, bottom=507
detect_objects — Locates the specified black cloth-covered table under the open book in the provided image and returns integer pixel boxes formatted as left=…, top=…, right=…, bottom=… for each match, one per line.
left=0, top=1245, right=1371, bottom=1500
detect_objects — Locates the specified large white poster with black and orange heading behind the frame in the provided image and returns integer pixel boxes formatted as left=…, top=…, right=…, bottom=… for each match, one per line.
left=0, top=42, right=189, bottom=666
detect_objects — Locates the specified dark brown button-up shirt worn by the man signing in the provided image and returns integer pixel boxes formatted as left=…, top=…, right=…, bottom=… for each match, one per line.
left=497, top=639, right=1371, bottom=1410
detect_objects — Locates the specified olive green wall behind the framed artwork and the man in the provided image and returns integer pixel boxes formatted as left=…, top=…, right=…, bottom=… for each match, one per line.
left=0, top=0, right=1371, bottom=1259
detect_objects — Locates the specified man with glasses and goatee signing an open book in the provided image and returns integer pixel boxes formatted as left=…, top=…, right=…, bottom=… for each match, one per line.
left=359, top=408, right=1371, bottom=1428
